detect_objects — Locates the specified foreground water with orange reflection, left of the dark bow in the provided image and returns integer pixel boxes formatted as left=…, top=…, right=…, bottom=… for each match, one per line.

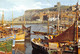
left=12, top=40, right=44, bottom=54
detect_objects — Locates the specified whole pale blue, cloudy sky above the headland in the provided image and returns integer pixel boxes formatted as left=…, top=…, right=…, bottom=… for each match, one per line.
left=0, top=0, right=80, bottom=20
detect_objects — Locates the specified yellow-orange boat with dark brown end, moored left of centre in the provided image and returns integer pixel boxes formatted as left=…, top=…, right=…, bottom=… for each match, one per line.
left=15, top=27, right=31, bottom=41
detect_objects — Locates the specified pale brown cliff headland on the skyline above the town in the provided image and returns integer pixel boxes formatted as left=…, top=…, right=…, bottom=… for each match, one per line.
left=14, top=5, right=70, bottom=21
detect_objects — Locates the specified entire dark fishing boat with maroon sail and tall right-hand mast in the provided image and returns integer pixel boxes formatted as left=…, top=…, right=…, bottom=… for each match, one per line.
left=31, top=2, right=78, bottom=54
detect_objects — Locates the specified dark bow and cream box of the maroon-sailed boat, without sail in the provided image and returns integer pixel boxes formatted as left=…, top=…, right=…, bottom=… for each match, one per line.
left=31, top=39, right=59, bottom=54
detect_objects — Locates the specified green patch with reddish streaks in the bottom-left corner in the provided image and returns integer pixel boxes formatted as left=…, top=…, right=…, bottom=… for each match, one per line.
left=0, top=40, right=13, bottom=52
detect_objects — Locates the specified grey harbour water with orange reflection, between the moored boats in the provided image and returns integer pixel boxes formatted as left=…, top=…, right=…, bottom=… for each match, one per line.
left=13, top=24, right=47, bottom=54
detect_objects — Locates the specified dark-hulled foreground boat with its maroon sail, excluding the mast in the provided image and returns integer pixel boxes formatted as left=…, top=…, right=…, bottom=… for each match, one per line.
left=31, top=24, right=75, bottom=53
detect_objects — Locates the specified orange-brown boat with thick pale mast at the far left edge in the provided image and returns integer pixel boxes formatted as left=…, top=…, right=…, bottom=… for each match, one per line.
left=0, top=11, right=12, bottom=38
